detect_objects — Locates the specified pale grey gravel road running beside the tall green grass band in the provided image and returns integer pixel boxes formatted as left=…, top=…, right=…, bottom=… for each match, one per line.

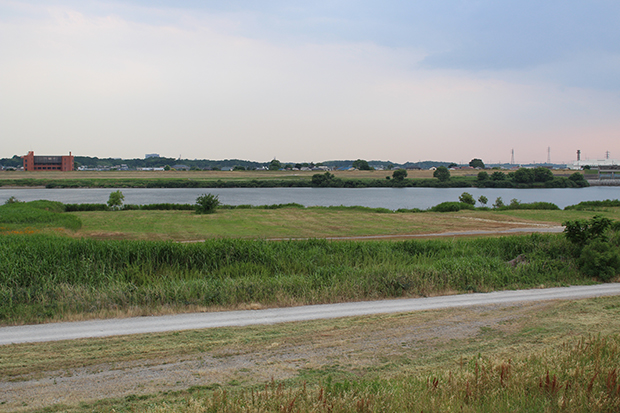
left=0, top=283, right=620, bottom=345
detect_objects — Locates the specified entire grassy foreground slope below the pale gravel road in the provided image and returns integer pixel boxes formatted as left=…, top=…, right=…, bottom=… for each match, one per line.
left=0, top=297, right=620, bottom=412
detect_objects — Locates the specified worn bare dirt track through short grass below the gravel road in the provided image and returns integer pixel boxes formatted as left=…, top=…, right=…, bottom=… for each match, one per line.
left=0, top=303, right=550, bottom=411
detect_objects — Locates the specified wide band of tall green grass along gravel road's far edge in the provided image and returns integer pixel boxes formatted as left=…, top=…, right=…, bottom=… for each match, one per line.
left=0, top=234, right=588, bottom=324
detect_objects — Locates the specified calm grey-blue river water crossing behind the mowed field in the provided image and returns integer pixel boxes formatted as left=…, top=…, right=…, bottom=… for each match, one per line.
left=0, top=186, right=620, bottom=210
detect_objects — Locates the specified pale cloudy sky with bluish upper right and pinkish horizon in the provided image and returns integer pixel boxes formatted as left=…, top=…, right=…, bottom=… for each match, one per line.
left=0, top=0, right=620, bottom=163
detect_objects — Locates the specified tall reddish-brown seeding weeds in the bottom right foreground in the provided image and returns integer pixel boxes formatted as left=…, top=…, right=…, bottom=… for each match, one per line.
left=147, top=335, right=620, bottom=413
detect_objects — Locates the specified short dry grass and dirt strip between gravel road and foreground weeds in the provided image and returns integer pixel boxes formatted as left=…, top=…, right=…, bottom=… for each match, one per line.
left=0, top=297, right=620, bottom=411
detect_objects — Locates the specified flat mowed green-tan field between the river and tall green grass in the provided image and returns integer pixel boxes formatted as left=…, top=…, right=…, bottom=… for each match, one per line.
left=71, top=208, right=620, bottom=241
